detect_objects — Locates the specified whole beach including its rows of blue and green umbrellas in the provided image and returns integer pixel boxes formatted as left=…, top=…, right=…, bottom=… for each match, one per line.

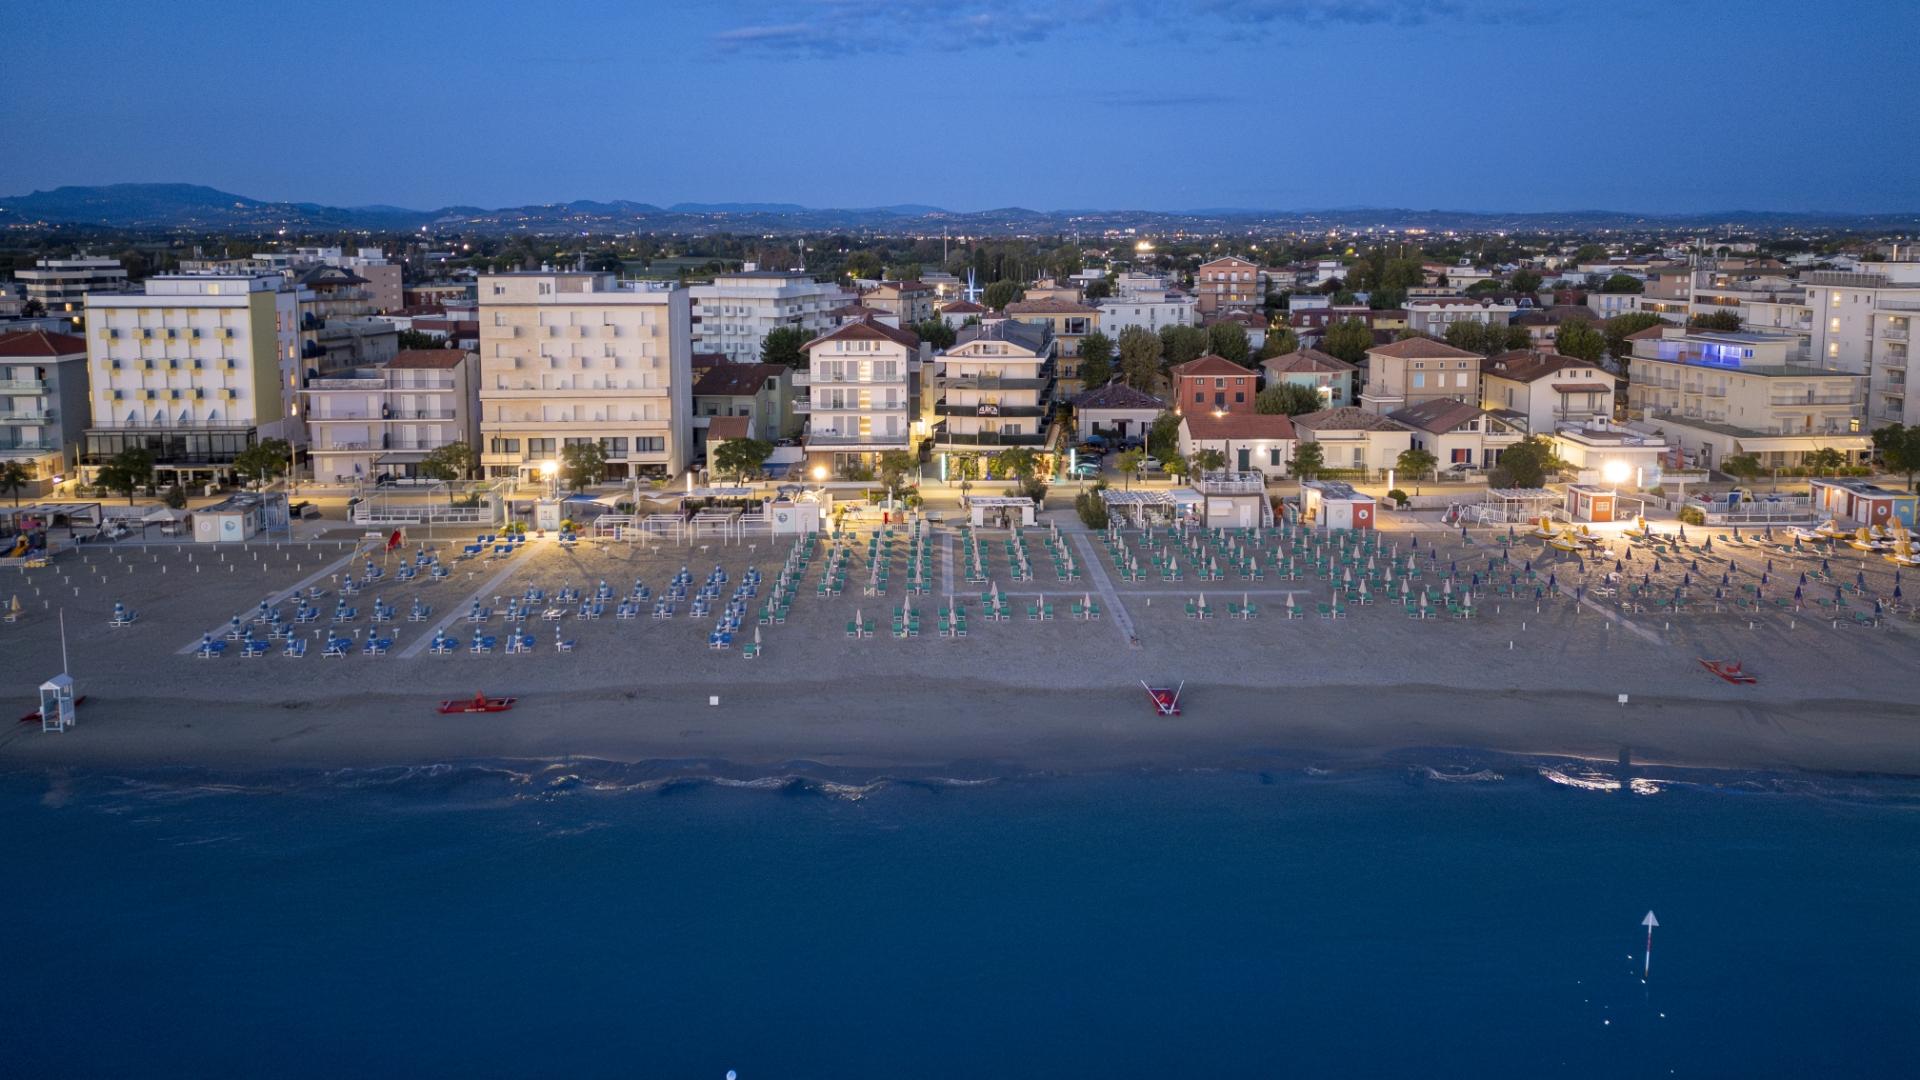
left=0, top=519, right=1920, bottom=765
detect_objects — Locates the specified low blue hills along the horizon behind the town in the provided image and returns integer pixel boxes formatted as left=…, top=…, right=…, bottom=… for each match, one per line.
left=0, top=184, right=1920, bottom=234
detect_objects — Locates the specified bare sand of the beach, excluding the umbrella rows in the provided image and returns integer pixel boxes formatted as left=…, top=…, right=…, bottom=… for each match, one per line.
left=0, top=511, right=1920, bottom=774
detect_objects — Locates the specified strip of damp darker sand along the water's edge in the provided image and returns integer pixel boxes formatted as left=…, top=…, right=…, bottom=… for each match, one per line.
left=15, top=680, right=1920, bottom=778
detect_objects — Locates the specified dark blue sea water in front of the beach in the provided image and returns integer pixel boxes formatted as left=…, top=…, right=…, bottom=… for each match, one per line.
left=0, top=763, right=1920, bottom=1080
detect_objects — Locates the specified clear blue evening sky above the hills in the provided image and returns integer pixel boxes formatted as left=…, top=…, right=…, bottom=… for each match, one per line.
left=11, top=0, right=1920, bottom=213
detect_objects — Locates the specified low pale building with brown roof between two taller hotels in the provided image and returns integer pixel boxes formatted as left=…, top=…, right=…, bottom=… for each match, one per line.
left=301, top=348, right=480, bottom=484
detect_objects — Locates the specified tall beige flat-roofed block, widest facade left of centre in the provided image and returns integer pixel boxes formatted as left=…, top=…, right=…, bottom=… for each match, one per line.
left=480, top=269, right=693, bottom=479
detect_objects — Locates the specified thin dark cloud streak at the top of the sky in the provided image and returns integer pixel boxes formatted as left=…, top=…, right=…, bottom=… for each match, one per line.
left=712, top=0, right=1544, bottom=56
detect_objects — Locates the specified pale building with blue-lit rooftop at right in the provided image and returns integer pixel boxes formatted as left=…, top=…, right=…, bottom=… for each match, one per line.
left=1628, top=327, right=1872, bottom=467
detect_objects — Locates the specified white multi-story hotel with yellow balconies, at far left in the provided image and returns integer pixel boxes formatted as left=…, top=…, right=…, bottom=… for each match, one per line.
left=81, top=273, right=305, bottom=484
